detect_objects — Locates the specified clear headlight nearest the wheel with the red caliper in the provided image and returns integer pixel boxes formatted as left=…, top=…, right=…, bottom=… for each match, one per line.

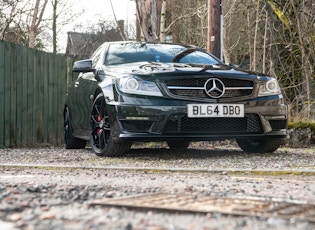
left=117, top=76, right=163, bottom=97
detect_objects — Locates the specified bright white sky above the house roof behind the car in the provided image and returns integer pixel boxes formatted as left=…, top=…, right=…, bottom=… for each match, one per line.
left=55, top=0, right=136, bottom=52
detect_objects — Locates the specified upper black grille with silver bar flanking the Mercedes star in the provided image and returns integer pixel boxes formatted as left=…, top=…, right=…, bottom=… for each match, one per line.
left=165, top=78, right=254, bottom=98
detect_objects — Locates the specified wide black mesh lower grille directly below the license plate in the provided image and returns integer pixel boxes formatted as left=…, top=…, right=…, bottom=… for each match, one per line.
left=163, top=114, right=263, bottom=135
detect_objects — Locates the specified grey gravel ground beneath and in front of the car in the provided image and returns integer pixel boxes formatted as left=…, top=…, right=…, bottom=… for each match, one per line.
left=0, top=142, right=315, bottom=230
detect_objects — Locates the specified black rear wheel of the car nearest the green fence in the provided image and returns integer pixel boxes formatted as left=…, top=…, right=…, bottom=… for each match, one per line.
left=63, top=107, right=86, bottom=149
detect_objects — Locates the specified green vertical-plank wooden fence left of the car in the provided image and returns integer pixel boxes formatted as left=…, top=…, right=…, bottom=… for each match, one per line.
left=0, top=41, right=69, bottom=147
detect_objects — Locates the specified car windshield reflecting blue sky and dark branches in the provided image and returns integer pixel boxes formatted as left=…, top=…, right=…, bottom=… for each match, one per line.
left=105, top=42, right=220, bottom=65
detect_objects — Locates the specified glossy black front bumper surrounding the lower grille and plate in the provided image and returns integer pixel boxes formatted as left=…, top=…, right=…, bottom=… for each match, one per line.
left=110, top=96, right=287, bottom=141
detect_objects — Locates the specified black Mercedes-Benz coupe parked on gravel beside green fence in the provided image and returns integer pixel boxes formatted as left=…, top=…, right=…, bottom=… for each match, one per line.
left=64, top=41, right=288, bottom=156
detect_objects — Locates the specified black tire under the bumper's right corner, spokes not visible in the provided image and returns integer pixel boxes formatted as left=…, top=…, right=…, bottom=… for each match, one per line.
left=236, top=138, right=283, bottom=153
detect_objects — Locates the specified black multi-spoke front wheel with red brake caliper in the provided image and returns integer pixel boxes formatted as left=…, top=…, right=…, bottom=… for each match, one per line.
left=90, top=93, right=132, bottom=157
